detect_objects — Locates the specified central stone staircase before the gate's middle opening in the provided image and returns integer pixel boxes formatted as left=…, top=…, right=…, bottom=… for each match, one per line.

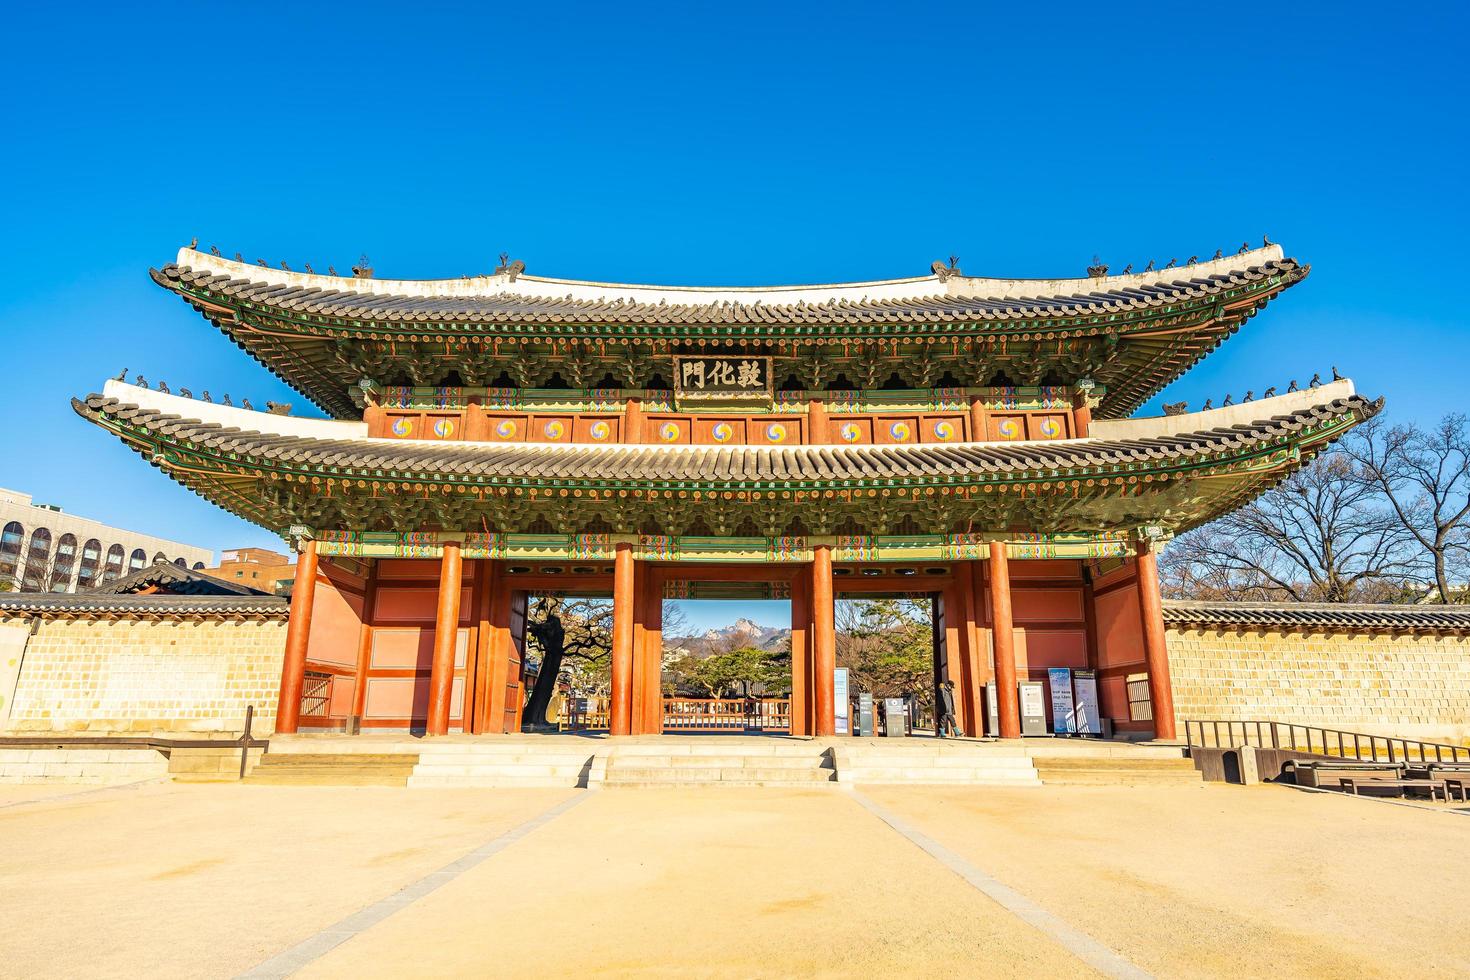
left=592, top=738, right=836, bottom=789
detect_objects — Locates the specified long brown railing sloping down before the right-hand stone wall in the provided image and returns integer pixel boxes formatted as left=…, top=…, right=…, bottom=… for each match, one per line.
left=1185, top=718, right=1470, bottom=763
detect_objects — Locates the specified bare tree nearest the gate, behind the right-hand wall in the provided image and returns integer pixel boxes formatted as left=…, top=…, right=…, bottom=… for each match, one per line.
left=1163, top=448, right=1414, bottom=602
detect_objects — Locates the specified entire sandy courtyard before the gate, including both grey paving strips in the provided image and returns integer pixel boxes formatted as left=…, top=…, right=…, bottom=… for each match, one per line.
left=0, top=783, right=1470, bottom=979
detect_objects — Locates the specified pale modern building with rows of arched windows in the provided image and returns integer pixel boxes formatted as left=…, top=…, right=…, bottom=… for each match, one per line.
left=0, top=489, right=215, bottom=592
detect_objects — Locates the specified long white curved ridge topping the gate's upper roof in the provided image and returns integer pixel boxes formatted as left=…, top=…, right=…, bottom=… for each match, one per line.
left=178, top=245, right=1282, bottom=306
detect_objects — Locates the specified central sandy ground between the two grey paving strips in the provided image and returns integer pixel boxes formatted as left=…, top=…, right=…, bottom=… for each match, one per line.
left=292, top=789, right=1088, bottom=977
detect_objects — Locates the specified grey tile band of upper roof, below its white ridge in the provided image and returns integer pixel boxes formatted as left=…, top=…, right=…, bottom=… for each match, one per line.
left=150, top=259, right=1307, bottom=325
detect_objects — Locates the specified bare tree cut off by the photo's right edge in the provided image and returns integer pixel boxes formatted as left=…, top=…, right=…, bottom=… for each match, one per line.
left=1344, top=414, right=1470, bottom=602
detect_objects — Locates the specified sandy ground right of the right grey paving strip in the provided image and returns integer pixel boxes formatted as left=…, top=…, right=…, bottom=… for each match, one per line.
left=867, top=785, right=1470, bottom=979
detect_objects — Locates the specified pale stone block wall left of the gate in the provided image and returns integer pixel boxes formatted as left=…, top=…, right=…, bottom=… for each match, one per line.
left=0, top=616, right=285, bottom=735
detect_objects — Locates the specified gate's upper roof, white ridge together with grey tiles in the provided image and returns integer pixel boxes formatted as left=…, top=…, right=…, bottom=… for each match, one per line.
left=151, top=247, right=1307, bottom=326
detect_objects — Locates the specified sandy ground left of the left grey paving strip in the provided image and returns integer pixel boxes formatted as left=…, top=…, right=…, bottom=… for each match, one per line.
left=0, top=783, right=576, bottom=977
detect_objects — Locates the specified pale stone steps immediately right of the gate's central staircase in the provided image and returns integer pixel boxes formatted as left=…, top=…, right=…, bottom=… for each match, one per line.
left=833, top=739, right=1041, bottom=786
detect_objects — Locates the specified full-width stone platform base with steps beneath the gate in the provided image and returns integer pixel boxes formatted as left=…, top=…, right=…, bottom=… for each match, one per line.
left=237, top=733, right=1200, bottom=789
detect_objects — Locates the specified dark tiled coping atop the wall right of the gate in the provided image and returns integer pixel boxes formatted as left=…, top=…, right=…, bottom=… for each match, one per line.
left=1164, top=599, right=1470, bottom=633
